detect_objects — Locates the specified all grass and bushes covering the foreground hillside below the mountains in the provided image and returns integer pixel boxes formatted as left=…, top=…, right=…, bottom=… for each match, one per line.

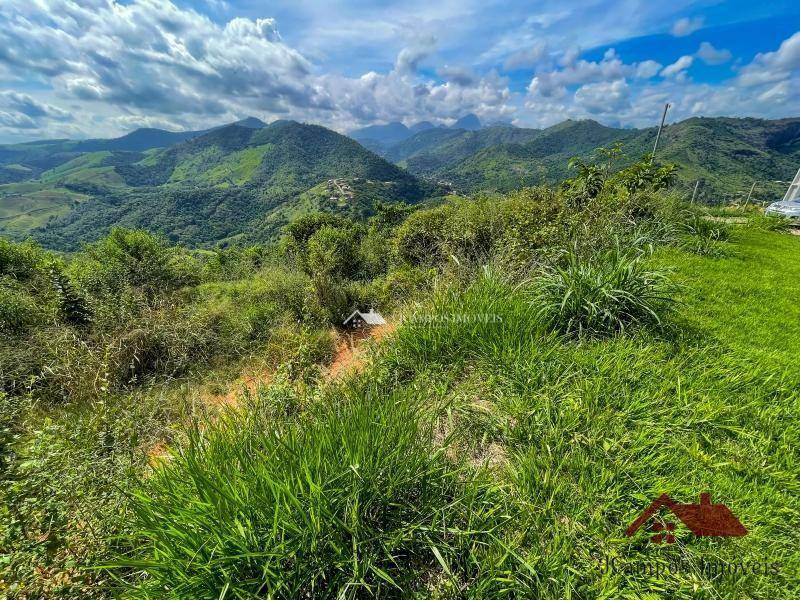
left=0, top=152, right=800, bottom=598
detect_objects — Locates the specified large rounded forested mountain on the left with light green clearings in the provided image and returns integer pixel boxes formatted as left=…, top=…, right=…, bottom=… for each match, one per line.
left=12, top=121, right=435, bottom=250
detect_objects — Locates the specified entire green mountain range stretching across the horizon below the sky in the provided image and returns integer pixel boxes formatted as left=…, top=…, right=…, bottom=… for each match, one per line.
left=0, top=115, right=800, bottom=251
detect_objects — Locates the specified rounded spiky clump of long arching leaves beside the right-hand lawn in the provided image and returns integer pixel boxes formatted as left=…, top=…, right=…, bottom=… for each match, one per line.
left=532, top=246, right=674, bottom=336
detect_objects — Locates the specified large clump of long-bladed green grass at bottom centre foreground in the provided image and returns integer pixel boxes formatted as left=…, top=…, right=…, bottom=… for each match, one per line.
left=120, top=388, right=500, bottom=598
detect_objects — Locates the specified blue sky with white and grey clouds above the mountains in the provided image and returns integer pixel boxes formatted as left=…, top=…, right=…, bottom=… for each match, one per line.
left=0, top=0, right=800, bottom=143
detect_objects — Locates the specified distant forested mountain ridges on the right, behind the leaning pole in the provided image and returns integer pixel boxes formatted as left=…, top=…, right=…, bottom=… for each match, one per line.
left=376, top=118, right=800, bottom=202
